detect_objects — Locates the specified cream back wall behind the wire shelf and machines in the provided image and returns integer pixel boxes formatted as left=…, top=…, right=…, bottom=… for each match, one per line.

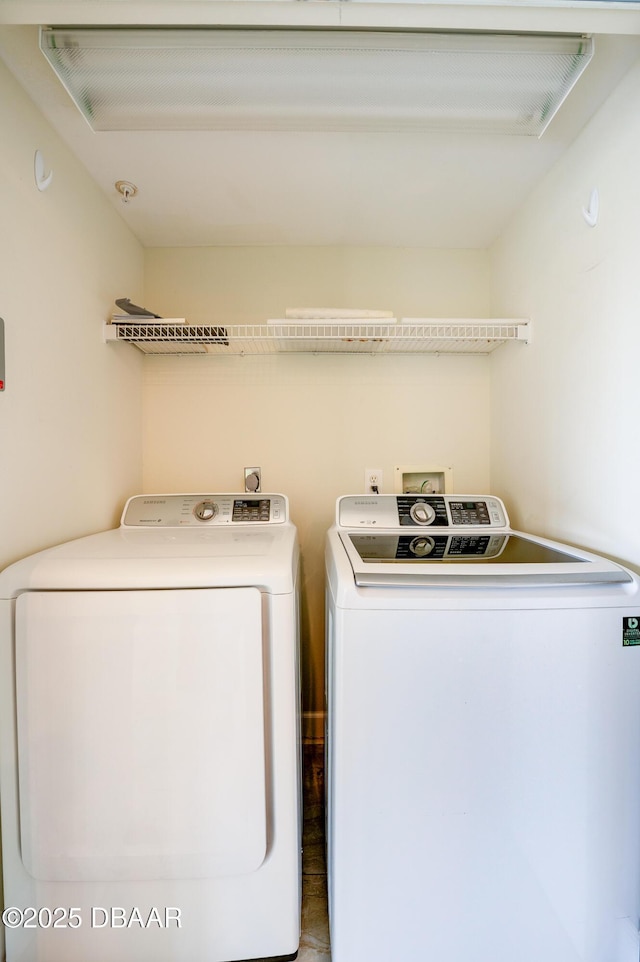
left=144, top=248, right=490, bottom=728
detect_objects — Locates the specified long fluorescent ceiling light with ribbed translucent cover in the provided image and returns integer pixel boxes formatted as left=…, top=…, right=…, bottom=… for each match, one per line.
left=40, top=28, right=593, bottom=136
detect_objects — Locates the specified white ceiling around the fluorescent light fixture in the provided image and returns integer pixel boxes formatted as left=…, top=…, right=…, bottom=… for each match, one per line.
left=0, top=0, right=640, bottom=248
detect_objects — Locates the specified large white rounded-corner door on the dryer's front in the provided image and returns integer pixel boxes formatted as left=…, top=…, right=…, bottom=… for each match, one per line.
left=16, top=588, right=267, bottom=881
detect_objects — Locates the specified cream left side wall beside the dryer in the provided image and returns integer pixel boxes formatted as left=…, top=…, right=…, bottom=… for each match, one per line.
left=0, top=58, right=143, bottom=567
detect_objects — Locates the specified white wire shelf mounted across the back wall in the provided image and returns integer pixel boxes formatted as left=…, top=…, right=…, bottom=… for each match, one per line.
left=105, top=319, right=530, bottom=356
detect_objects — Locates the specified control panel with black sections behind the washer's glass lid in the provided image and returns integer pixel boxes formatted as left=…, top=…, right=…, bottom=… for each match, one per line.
left=336, top=494, right=509, bottom=529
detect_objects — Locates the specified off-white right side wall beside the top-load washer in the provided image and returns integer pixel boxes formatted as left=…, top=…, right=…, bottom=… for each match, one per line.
left=491, top=56, right=640, bottom=566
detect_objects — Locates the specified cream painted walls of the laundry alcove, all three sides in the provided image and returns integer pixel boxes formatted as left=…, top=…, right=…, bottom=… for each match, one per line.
left=8, top=20, right=640, bottom=744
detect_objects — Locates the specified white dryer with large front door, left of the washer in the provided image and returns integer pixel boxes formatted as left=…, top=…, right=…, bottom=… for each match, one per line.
left=0, top=494, right=301, bottom=962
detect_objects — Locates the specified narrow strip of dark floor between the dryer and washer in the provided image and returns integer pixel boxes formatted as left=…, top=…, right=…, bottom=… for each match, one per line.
left=297, top=742, right=331, bottom=962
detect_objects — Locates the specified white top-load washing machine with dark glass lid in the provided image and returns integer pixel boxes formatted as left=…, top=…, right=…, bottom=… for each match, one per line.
left=326, top=495, right=640, bottom=962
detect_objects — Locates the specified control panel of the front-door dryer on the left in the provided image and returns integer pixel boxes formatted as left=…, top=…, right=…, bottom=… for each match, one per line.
left=120, top=494, right=289, bottom=528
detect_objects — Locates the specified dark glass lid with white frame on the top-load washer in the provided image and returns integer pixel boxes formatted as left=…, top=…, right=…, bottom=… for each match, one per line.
left=338, top=528, right=633, bottom=587
